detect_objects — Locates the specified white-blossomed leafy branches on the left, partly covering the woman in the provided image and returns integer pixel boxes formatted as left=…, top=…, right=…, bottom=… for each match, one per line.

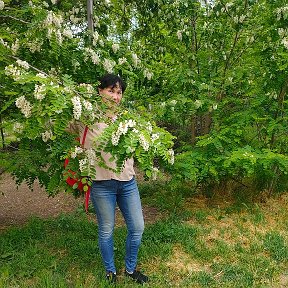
left=0, top=1, right=174, bottom=195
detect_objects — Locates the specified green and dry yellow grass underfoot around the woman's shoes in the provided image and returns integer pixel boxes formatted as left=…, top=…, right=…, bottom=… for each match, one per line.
left=0, top=180, right=288, bottom=288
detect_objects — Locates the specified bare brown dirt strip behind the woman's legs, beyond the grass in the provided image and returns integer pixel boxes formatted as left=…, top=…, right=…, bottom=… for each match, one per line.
left=0, top=173, right=161, bottom=230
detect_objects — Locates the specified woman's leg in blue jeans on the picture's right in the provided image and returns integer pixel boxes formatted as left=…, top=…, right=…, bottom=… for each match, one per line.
left=117, top=178, right=144, bottom=272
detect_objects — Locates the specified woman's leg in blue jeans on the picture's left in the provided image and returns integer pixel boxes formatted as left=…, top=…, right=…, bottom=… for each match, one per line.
left=90, top=180, right=117, bottom=273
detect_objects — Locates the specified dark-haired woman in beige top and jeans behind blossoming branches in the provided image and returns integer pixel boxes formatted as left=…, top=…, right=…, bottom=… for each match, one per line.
left=79, top=74, right=148, bottom=284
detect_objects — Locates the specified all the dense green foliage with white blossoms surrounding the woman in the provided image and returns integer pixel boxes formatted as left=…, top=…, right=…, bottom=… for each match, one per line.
left=0, top=0, right=288, bottom=197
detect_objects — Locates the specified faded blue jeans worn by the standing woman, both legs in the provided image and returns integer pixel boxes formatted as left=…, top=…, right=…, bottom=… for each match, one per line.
left=91, top=177, right=144, bottom=272
